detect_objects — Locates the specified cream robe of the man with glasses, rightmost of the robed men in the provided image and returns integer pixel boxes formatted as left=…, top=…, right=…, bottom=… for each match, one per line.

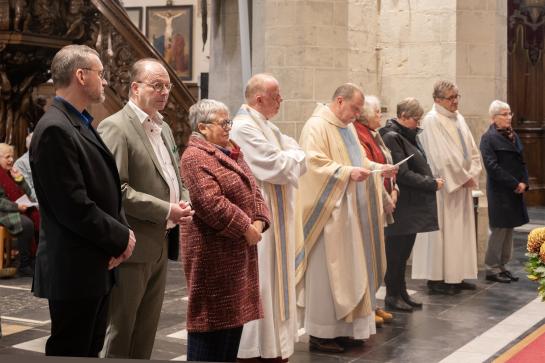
left=412, top=104, right=482, bottom=283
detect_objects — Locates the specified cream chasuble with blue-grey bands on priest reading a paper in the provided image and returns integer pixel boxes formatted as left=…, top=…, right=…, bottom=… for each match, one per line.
left=296, top=104, right=383, bottom=339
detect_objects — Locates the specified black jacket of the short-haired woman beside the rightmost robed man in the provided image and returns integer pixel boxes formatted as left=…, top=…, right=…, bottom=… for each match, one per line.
left=379, top=119, right=439, bottom=236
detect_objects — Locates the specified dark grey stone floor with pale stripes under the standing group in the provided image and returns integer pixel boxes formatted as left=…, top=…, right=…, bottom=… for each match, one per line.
left=0, top=210, right=545, bottom=363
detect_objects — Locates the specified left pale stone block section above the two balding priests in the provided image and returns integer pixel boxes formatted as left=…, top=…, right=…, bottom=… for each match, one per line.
left=248, top=0, right=377, bottom=138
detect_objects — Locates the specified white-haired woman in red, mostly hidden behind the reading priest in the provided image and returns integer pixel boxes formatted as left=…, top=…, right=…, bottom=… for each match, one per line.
left=354, top=95, right=399, bottom=327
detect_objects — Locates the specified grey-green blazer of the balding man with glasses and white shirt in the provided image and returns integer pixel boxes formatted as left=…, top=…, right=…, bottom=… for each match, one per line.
left=98, top=105, right=189, bottom=263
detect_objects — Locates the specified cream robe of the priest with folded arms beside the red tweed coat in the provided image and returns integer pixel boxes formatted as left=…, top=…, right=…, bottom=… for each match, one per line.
left=230, top=105, right=306, bottom=358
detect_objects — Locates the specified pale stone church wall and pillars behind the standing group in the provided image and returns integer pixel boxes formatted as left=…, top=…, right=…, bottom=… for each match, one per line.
left=206, top=0, right=507, bottom=265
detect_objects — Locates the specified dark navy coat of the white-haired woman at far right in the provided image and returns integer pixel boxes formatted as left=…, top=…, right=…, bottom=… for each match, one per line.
left=480, top=124, right=528, bottom=228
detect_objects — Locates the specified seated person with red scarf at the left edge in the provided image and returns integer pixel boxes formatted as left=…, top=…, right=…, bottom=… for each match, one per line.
left=0, top=143, right=40, bottom=276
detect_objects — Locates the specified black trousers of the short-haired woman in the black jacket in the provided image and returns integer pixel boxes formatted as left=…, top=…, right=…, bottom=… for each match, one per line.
left=384, top=233, right=416, bottom=296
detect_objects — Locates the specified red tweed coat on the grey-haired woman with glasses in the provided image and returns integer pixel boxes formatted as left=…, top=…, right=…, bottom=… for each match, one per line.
left=181, top=136, right=269, bottom=332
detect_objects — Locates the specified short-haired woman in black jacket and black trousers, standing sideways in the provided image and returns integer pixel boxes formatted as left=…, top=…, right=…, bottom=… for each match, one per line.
left=380, top=98, right=444, bottom=311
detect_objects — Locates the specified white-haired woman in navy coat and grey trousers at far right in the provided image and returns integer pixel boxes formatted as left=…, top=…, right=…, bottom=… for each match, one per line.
left=480, top=100, right=528, bottom=283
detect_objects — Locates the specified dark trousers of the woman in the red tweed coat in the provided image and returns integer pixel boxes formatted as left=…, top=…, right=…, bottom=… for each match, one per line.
left=187, top=327, right=242, bottom=362
